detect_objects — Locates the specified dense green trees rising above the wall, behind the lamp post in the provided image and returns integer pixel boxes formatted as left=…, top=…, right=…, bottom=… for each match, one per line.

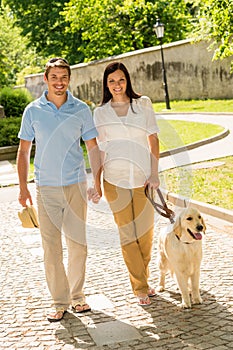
left=2, top=0, right=195, bottom=64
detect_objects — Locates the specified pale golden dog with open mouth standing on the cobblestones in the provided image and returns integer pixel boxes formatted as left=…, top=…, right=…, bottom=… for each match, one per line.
left=158, top=207, right=206, bottom=308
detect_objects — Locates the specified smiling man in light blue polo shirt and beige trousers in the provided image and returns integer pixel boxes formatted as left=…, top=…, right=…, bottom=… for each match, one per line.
left=17, top=58, right=101, bottom=322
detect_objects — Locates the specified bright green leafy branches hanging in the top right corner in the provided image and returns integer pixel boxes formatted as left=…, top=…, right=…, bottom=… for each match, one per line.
left=194, top=0, right=233, bottom=70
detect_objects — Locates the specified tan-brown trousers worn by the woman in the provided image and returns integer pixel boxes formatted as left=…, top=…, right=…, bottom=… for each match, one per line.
left=104, top=181, right=154, bottom=295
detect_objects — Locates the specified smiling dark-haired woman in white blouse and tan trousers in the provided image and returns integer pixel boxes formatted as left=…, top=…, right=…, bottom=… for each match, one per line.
left=94, top=62, right=159, bottom=306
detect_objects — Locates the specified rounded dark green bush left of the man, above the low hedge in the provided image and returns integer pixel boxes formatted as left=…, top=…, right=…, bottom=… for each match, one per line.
left=0, top=87, right=32, bottom=117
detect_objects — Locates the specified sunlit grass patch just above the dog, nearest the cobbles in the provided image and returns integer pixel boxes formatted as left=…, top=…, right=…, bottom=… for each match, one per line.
left=161, top=156, right=233, bottom=210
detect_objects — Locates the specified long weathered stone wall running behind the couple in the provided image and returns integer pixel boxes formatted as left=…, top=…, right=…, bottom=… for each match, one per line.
left=25, top=40, right=233, bottom=103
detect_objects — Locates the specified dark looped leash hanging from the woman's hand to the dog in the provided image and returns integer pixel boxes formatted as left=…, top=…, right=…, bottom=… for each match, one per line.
left=145, top=185, right=175, bottom=224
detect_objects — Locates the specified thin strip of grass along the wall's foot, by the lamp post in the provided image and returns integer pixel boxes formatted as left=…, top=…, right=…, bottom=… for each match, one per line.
left=153, top=100, right=233, bottom=113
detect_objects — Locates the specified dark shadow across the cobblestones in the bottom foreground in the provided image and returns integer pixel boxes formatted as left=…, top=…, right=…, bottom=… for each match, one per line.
left=55, top=291, right=233, bottom=350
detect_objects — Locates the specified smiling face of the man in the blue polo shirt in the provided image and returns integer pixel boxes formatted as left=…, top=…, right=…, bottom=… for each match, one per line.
left=44, top=67, right=70, bottom=96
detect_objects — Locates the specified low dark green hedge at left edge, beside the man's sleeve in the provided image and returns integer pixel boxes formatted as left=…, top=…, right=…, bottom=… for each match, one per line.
left=0, top=117, right=21, bottom=147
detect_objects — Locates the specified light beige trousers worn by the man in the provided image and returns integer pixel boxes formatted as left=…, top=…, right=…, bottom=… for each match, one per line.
left=37, top=183, right=87, bottom=309
